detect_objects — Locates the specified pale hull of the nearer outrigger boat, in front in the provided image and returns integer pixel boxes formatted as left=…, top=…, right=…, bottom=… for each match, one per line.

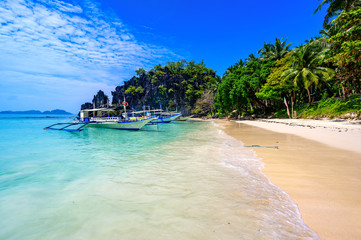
left=86, top=118, right=154, bottom=131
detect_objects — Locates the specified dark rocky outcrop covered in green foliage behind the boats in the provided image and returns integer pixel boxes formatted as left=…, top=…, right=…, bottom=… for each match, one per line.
left=113, top=60, right=220, bottom=113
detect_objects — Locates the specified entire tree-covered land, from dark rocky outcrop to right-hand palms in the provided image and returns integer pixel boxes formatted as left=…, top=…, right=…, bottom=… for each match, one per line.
left=82, top=0, right=361, bottom=118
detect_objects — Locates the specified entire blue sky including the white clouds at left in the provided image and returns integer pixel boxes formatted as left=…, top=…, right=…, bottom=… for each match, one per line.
left=0, top=0, right=325, bottom=113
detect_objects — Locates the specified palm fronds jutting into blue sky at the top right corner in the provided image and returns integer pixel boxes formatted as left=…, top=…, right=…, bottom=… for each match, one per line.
left=313, top=0, right=361, bottom=27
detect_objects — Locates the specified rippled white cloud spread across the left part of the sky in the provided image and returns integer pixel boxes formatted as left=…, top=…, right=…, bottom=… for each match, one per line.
left=0, top=0, right=179, bottom=110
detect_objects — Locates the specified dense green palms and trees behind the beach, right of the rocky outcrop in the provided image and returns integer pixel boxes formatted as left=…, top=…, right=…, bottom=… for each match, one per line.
left=215, top=0, right=361, bottom=117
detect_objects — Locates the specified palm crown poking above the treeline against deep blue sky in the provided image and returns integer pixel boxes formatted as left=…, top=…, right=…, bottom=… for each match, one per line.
left=258, top=38, right=291, bottom=60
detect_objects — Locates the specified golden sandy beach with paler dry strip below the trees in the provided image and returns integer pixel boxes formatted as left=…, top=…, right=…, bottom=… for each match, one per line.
left=218, top=119, right=361, bottom=239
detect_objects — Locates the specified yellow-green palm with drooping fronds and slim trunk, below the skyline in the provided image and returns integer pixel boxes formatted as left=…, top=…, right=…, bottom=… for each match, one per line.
left=282, top=43, right=334, bottom=104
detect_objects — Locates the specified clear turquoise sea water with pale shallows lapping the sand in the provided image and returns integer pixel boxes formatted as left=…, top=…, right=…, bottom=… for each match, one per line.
left=0, top=115, right=319, bottom=240
